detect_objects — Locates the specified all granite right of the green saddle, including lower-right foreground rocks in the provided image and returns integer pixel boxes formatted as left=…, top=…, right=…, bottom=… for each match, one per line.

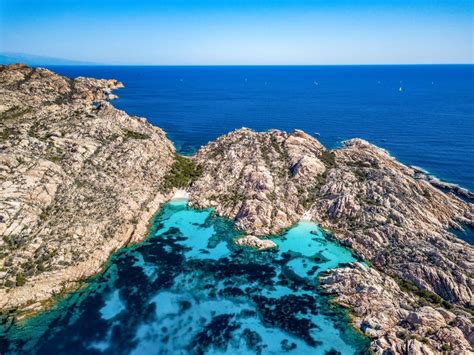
left=190, top=129, right=474, bottom=354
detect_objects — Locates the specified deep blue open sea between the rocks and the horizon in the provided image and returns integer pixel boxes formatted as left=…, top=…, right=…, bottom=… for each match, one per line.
left=49, top=65, right=474, bottom=191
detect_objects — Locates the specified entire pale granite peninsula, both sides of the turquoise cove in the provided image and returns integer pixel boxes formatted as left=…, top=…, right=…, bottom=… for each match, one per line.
left=0, top=65, right=474, bottom=354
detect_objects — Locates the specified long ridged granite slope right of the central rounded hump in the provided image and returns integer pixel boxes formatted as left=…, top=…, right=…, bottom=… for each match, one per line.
left=312, top=139, right=474, bottom=307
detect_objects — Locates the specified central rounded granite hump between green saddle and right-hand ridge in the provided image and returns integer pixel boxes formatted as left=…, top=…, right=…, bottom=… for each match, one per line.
left=190, top=129, right=326, bottom=235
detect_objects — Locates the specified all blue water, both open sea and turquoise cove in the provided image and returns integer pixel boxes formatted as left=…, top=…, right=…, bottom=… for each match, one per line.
left=0, top=66, right=474, bottom=355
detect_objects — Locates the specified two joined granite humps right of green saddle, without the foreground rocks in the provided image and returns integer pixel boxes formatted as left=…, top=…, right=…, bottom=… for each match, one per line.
left=190, top=129, right=474, bottom=307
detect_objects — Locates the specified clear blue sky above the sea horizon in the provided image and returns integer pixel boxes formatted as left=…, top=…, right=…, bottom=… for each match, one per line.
left=0, top=0, right=474, bottom=65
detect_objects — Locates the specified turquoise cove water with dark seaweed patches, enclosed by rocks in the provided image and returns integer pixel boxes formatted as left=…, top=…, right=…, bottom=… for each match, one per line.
left=0, top=201, right=368, bottom=354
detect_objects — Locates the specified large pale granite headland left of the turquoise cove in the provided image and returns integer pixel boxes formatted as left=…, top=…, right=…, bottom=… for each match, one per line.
left=0, top=65, right=175, bottom=309
